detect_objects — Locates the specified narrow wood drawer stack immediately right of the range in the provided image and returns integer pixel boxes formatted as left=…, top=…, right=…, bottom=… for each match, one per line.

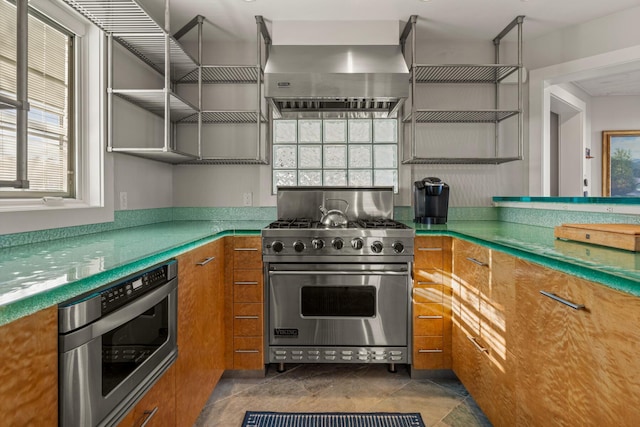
left=412, top=236, right=451, bottom=369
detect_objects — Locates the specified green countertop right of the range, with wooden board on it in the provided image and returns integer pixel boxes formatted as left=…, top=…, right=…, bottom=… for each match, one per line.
left=414, top=221, right=640, bottom=296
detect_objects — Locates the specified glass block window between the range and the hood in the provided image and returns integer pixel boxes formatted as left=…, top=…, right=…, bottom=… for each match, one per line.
left=272, top=119, right=398, bottom=194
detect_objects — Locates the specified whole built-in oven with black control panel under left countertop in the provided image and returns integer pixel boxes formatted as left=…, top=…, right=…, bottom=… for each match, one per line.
left=58, top=260, right=178, bottom=427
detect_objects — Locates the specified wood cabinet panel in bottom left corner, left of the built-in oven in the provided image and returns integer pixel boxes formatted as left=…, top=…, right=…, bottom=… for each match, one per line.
left=0, top=306, right=58, bottom=427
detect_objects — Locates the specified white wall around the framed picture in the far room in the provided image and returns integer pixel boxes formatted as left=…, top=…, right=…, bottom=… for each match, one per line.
left=591, top=96, right=640, bottom=195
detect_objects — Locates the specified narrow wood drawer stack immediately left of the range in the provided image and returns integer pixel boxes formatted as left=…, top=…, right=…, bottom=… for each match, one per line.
left=226, top=236, right=264, bottom=370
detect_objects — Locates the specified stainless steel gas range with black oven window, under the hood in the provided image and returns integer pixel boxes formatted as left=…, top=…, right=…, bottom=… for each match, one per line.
left=262, top=187, right=414, bottom=371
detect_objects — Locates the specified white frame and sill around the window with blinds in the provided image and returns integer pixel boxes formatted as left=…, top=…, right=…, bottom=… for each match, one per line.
left=0, top=0, right=114, bottom=235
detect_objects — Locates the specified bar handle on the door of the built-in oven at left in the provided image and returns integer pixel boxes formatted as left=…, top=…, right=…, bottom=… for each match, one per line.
left=58, top=278, right=178, bottom=353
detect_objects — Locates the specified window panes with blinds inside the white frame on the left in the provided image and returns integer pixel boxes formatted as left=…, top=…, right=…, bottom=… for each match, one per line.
left=0, top=0, right=75, bottom=198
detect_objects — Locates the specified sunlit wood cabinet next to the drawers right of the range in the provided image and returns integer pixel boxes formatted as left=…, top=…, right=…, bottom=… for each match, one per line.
left=452, top=239, right=517, bottom=426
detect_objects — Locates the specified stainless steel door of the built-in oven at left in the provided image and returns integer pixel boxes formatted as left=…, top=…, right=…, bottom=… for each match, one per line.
left=59, top=279, right=177, bottom=427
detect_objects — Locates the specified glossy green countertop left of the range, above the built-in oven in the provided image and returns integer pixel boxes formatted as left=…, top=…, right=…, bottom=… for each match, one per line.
left=0, top=221, right=269, bottom=324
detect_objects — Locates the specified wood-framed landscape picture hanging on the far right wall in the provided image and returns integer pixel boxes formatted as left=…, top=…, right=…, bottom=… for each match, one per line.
left=602, top=130, right=640, bottom=197
